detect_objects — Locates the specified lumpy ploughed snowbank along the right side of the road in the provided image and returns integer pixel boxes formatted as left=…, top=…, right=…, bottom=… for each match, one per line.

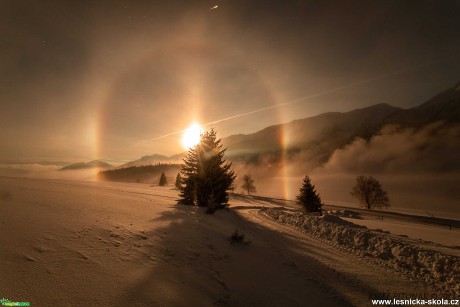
left=261, top=208, right=460, bottom=295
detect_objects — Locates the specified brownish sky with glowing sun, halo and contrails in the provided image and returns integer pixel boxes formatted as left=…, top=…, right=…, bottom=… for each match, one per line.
left=0, top=0, right=460, bottom=162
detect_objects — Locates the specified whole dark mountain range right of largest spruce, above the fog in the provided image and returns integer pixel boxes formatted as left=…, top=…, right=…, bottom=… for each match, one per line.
left=222, top=82, right=460, bottom=171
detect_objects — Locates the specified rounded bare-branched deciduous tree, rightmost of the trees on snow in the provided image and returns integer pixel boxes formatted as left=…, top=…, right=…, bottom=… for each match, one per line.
left=350, top=176, right=390, bottom=209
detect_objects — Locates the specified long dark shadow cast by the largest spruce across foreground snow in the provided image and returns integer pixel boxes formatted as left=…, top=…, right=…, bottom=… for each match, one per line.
left=115, top=205, right=398, bottom=306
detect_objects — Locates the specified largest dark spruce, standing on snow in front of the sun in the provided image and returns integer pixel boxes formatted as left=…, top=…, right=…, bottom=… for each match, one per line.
left=178, top=129, right=235, bottom=213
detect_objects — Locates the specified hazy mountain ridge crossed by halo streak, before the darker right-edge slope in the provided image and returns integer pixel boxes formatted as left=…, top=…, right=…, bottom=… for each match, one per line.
left=222, top=104, right=401, bottom=162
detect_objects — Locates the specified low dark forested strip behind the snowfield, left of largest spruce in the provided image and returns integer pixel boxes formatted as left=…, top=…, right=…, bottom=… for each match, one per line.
left=97, top=163, right=181, bottom=183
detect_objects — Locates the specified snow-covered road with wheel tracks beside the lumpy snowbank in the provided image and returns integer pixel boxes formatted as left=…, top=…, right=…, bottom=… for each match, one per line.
left=240, top=210, right=434, bottom=306
